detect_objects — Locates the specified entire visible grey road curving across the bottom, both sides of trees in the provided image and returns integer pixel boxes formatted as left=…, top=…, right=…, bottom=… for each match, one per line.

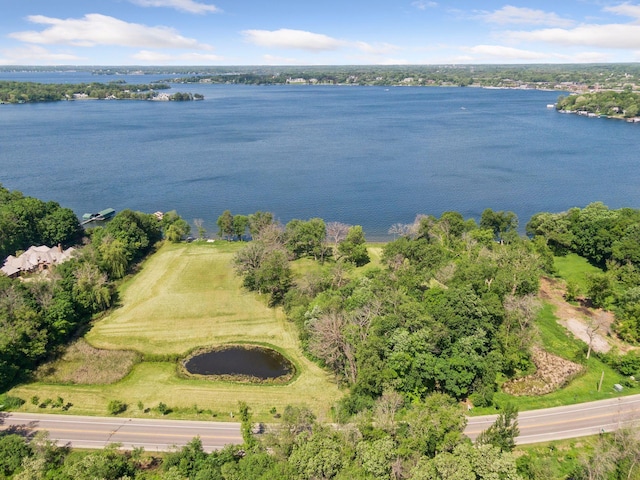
left=0, top=395, right=640, bottom=452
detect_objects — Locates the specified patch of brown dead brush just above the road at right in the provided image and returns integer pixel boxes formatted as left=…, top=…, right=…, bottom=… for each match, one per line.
left=502, top=347, right=584, bottom=396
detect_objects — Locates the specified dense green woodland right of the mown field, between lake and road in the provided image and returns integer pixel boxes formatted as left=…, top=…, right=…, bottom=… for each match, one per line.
left=229, top=203, right=640, bottom=412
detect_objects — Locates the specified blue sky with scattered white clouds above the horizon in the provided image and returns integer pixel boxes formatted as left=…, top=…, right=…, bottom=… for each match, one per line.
left=0, top=0, right=640, bottom=66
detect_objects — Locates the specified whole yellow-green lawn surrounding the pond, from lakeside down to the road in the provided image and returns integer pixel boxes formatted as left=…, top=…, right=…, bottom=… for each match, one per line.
left=12, top=242, right=343, bottom=421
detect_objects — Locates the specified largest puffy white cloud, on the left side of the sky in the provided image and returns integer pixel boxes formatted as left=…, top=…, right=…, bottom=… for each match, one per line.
left=9, top=13, right=211, bottom=50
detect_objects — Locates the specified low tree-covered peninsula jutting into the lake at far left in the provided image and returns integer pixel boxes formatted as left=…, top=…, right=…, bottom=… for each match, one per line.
left=0, top=81, right=202, bottom=103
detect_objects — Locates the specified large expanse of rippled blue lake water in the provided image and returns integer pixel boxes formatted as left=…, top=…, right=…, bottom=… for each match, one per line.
left=0, top=73, right=640, bottom=239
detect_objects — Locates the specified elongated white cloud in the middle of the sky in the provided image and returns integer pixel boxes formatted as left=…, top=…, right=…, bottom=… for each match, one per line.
left=241, top=28, right=345, bottom=52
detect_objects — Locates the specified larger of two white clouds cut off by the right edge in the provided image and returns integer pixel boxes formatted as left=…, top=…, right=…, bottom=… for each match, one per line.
left=505, top=24, right=640, bottom=50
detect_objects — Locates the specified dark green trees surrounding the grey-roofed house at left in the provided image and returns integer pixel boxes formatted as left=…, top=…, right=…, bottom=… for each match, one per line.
left=0, top=185, right=189, bottom=391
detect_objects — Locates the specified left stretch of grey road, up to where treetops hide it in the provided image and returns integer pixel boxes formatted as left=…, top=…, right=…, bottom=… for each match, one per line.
left=0, top=413, right=242, bottom=452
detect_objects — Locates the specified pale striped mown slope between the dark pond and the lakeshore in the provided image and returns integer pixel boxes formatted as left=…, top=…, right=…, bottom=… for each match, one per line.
left=87, top=244, right=292, bottom=354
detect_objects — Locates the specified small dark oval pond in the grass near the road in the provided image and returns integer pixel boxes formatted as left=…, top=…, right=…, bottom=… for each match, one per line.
left=184, top=346, right=294, bottom=380
